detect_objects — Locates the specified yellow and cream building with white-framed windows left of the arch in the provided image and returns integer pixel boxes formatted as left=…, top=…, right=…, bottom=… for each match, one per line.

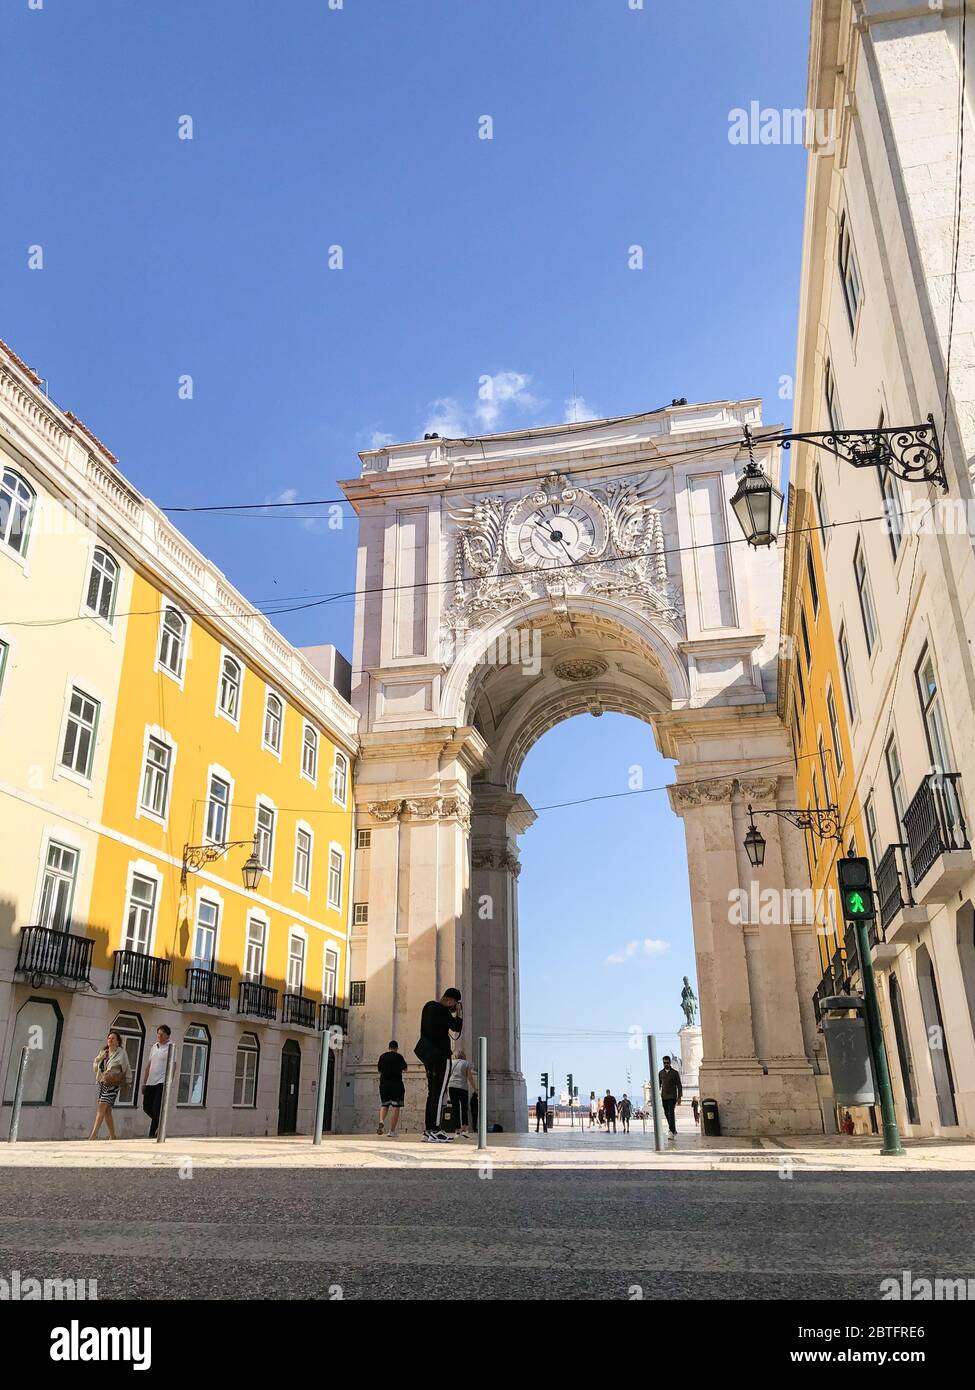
left=0, top=344, right=356, bottom=1137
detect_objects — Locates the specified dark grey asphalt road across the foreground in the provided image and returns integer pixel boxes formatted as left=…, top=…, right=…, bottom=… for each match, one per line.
left=0, top=1166, right=975, bottom=1300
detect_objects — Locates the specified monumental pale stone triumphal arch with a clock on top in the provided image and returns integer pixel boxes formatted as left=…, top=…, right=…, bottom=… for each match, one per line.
left=341, top=400, right=822, bottom=1134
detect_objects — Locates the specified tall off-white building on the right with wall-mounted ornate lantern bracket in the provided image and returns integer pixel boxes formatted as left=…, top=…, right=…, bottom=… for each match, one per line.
left=793, top=0, right=975, bottom=1136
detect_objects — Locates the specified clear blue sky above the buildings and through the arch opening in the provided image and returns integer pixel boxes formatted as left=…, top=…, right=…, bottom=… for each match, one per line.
left=0, top=0, right=808, bottom=1106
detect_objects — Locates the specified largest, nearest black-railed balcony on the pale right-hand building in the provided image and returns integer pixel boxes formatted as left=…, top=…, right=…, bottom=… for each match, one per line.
left=904, top=773, right=975, bottom=904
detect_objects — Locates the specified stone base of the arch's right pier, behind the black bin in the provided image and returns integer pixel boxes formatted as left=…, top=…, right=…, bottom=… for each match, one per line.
left=700, top=1059, right=823, bottom=1136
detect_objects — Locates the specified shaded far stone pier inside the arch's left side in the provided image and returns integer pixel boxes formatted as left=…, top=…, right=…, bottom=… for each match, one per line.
left=469, top=783, right=535, bottom=1133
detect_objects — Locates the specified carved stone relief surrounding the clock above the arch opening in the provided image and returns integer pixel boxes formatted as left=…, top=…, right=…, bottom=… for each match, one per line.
left=441, top=470, right=683, bottom=663
